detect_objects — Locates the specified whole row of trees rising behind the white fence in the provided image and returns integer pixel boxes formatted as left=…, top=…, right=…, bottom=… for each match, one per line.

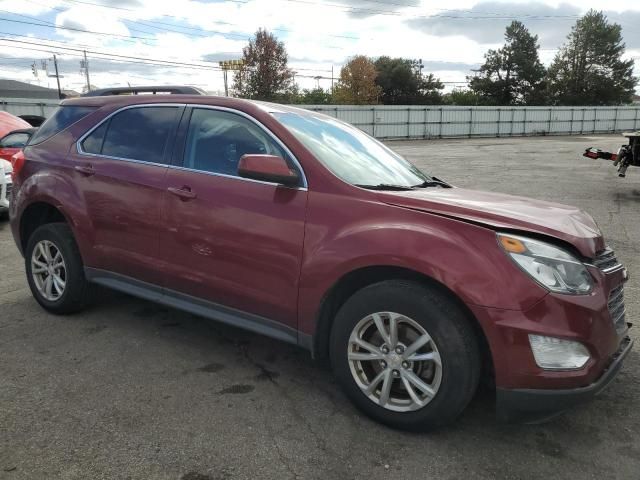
left=233, top=10, right=638, bottom=106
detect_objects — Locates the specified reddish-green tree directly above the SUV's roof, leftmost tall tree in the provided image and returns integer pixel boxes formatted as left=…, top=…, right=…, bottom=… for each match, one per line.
left=233, top=29, right=295, bottom=101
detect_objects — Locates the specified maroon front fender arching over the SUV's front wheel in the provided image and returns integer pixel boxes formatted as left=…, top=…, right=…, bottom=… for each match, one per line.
left=299, top=192, right=547, bottom=334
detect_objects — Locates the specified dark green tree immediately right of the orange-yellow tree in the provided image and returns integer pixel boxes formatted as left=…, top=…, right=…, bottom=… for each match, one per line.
left=375, top=57, right=444, bottom=105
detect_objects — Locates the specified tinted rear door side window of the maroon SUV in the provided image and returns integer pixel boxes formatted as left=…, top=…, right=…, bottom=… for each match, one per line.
left=82, top=106, right=180, bottom=164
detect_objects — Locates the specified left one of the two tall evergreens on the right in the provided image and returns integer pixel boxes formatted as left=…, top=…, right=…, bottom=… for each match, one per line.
left=469, top=21, right=545, bottom=105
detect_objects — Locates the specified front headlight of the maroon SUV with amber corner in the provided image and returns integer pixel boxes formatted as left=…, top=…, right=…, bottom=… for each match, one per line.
left=498, top=233, right=593, bottom=295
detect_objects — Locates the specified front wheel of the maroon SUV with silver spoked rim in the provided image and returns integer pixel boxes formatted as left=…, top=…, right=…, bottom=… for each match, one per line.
left=330, top=280, right=481, bottom=431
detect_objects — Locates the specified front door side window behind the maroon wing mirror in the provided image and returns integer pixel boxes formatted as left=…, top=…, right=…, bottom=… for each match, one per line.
left=183, top=108, right=287, bottom=177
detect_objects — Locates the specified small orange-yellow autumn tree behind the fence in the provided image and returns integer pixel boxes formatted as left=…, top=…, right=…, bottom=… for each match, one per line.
left=334, top=55, right=381, bottom=105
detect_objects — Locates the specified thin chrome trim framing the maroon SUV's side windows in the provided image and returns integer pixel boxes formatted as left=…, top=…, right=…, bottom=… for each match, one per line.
left=76, top=103, right=309, bottom=191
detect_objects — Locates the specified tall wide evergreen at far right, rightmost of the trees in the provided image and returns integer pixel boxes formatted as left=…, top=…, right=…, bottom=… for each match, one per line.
left=548, top=10, right=638, bottom=105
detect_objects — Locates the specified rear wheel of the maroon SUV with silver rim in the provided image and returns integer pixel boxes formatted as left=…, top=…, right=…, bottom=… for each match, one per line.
left=25, top=223, right=91, bottom=315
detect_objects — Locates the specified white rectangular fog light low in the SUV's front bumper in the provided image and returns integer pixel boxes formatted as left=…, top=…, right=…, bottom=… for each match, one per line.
left=529, top=335, right=590, bottom=370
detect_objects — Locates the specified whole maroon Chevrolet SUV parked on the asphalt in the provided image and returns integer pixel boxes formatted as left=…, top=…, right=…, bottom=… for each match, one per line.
left=10, top=94, right=632, bottom=430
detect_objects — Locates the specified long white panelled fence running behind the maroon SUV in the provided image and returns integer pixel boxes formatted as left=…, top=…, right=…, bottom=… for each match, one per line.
left=0, top=99, right=640, bottom=139
